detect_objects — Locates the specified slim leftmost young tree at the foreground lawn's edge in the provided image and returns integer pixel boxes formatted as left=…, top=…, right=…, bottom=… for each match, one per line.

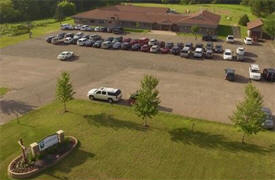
left=56, top=72, right=75, bottom=112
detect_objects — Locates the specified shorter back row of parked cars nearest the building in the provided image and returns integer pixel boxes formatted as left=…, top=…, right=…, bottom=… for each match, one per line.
left=60, top=24, right=124, bottom=34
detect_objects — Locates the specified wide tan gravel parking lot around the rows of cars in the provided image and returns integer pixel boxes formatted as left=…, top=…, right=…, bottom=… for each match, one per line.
left=0, top=30, right=275, bottom=123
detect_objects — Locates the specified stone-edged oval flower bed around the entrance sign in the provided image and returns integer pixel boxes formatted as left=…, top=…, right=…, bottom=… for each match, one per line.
left=8, top=136, right=78, bottom=178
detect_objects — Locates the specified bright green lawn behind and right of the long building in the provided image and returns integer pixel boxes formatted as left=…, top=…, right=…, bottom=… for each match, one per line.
left=132, top=3, right=257, bottom=37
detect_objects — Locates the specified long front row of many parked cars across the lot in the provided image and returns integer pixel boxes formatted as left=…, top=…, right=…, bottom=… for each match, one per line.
left=46, top=32, right=252, bottom=60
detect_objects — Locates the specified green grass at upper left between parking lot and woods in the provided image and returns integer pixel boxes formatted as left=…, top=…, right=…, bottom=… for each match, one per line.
left=0, top=18, right=73, bottom=48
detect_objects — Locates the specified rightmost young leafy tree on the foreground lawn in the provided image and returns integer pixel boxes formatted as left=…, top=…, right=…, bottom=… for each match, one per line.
left=230, top=83, right=265, bottom=143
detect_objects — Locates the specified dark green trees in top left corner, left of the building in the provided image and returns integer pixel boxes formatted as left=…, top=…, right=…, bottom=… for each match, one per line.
left=0, top=0, right=121, bottom=23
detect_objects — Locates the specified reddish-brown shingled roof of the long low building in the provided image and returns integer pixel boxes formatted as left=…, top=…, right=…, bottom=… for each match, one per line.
left=73, top=5, right=220, bottom=26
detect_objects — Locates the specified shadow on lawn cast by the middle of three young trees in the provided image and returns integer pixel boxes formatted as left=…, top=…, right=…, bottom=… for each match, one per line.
left=84, top=113, right=146, bottom=131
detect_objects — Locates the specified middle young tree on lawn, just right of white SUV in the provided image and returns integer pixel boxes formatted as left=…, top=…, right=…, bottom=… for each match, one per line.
left=134, top=75, right=160, bottom=127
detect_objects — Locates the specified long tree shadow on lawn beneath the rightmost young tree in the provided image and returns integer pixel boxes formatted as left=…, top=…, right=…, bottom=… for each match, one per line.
left=169, top=128, right=271, bottom=154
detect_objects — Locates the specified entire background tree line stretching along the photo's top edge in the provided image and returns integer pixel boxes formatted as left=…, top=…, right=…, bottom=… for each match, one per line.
left=0, top=0, right=275, bottom=23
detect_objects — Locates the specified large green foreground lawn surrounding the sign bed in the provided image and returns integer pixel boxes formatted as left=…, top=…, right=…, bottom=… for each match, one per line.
left=0, top=100, right=275, bottom=180
